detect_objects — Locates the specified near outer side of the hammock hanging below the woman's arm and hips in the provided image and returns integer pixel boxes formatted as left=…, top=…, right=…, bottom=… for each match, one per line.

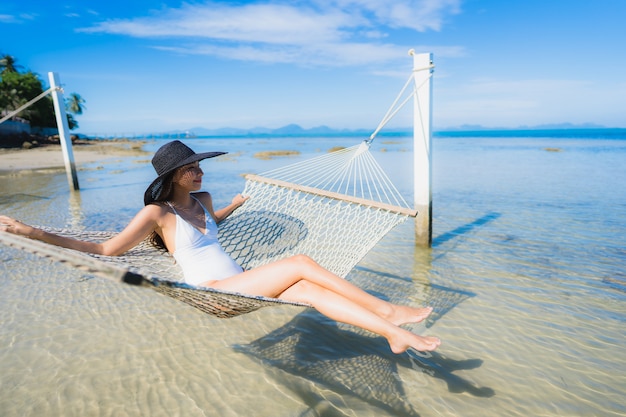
left=0, top=232, right=310, bottom=318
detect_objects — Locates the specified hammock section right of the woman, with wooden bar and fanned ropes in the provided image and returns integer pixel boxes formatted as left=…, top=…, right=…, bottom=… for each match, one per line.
left=220, top=142, right=417, bottom=277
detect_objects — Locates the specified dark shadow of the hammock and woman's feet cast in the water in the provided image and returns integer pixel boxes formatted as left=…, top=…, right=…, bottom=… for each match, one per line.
left=235, top=267, right=494, bottom=416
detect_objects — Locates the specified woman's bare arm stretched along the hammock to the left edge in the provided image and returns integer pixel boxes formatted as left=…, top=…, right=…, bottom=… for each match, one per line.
left=0, top=204, right=162, bottom=256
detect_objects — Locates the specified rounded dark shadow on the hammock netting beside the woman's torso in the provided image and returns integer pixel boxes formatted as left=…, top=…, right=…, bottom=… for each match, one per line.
left=219, top=210, right=308, bottom=269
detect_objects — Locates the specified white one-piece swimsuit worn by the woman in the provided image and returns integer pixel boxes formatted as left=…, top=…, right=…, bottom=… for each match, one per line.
left=168, top=196, right=243, bottom=285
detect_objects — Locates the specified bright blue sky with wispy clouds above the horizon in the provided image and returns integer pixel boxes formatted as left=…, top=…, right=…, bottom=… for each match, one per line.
left=0, top=0, right=626, bottom=134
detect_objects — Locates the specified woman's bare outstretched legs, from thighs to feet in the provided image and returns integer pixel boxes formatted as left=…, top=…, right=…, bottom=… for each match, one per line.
left=207, top=256, right=441, bottom=353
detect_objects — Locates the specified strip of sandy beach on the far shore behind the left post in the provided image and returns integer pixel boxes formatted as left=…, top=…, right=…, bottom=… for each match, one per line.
left=0, top=140, right=150, bottom=174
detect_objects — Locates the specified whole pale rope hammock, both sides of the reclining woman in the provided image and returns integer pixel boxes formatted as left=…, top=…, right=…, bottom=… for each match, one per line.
left=0, top=141, right=416, bottom=318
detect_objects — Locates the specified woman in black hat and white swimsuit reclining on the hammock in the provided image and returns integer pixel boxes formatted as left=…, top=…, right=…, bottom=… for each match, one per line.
left=0, top=141, right=441, bottom=353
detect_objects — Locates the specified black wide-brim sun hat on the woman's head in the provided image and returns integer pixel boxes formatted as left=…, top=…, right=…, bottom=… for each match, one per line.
left=143, top=140, right=227, bottom=206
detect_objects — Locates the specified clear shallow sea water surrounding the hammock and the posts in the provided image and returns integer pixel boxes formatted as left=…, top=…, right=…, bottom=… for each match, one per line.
left=0, top=129, right=626, bottom=417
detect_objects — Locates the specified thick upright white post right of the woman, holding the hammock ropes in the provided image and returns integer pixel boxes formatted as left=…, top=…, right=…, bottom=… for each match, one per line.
left=409, top=50, right=433, bottom=246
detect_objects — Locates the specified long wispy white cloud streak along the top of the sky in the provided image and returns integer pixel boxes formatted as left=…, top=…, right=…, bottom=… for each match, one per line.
left=79, top=0, right=460, bottom=66
